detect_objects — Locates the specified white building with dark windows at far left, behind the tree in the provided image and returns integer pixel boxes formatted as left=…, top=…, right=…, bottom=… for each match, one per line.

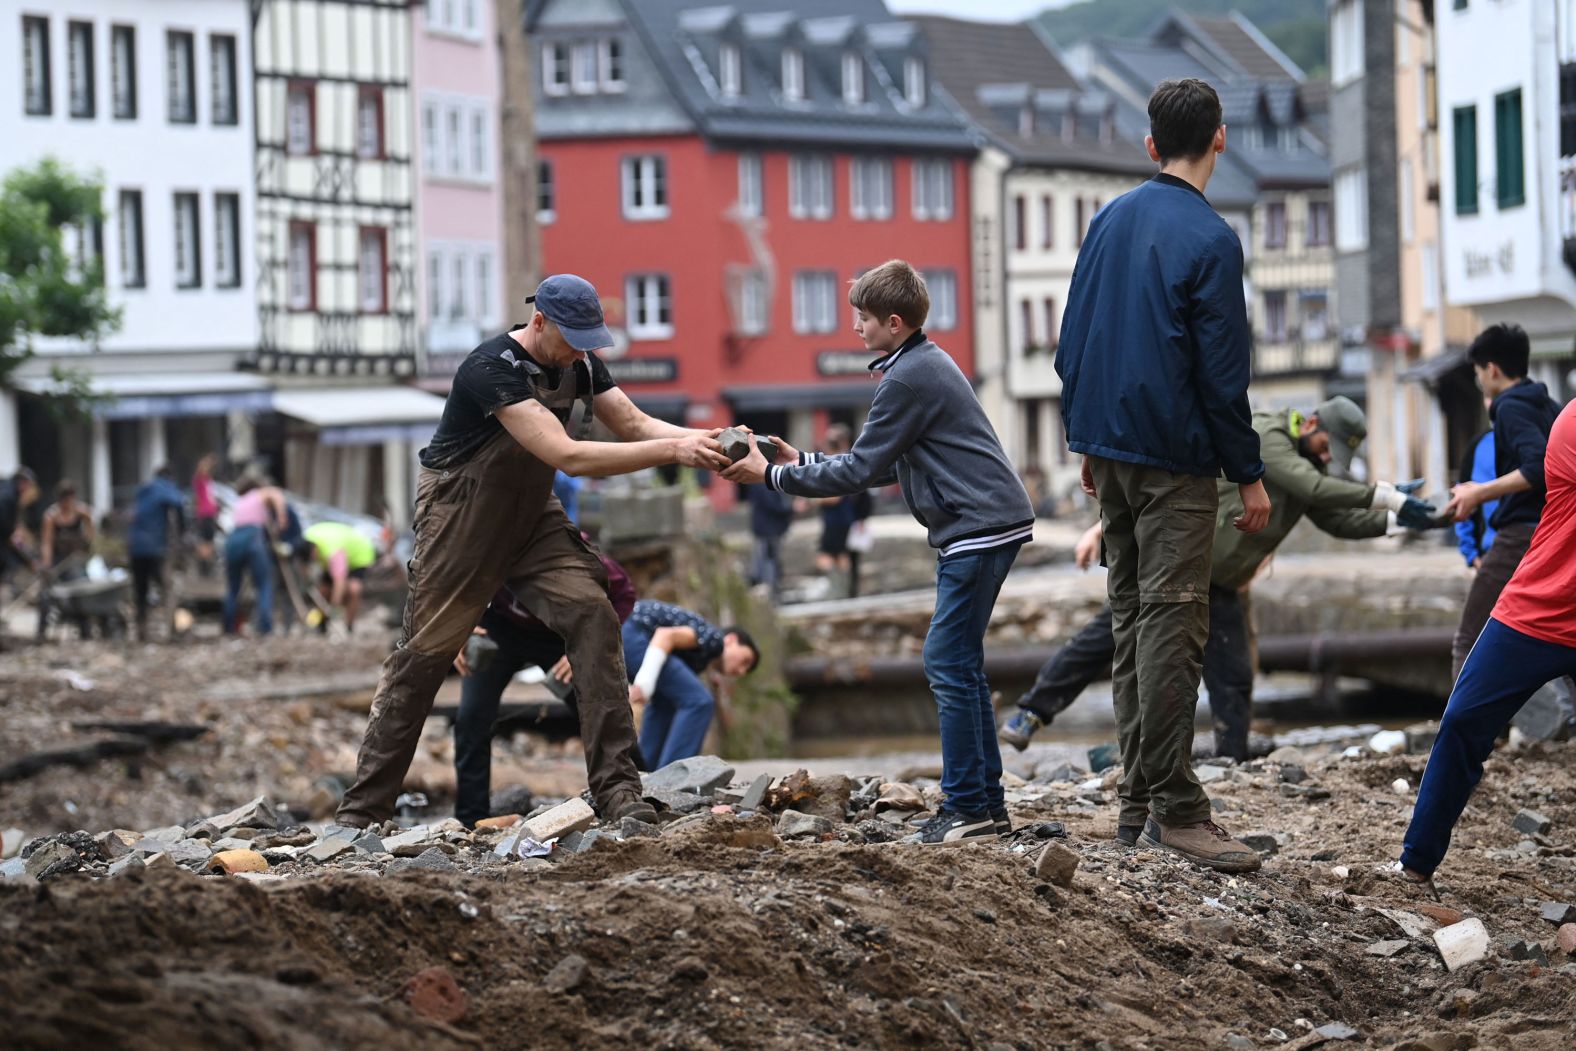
left=0, top=0, right=268, bottom=509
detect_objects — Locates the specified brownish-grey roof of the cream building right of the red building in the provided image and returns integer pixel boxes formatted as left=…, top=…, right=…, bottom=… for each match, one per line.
left=909, top=16, right=1154, bottom=175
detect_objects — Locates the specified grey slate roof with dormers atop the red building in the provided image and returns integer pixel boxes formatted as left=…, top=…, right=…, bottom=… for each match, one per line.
left=608, top=0, right=977, bottom=153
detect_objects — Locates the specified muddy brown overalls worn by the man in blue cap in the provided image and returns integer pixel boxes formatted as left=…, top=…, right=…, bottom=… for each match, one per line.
left=337, top=361, right=640, bottom=827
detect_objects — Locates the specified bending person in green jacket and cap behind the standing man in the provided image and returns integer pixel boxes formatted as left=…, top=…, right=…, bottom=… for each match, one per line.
left=1001, top=397, right=1437, bottom=797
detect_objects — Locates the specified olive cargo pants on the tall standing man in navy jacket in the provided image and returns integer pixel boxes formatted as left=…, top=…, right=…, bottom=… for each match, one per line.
left=1089, top=457, right=1217, bottom=826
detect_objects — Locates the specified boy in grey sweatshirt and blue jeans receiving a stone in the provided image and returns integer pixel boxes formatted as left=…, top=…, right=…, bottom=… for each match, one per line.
left=722, top=260, right=1034, bottom=846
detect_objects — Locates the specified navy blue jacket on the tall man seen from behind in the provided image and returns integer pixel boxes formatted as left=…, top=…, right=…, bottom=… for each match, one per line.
left=1056, top=175, right=1264, bottom=484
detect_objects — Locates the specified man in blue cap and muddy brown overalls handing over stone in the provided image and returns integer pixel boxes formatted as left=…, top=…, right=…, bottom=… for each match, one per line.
left=339, top=274, right=728, bottom=827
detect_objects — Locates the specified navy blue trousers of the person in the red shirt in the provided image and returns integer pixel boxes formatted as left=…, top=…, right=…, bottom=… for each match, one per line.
left=1401, top=618, right=1576, bottom=876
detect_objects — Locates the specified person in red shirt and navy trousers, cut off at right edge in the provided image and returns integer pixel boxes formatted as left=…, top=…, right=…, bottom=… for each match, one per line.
left=1401, top=402, right=1576, bottom=884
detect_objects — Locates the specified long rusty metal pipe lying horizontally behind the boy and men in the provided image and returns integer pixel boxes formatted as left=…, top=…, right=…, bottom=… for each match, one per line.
left=785, top=627, right=1455, bottom=692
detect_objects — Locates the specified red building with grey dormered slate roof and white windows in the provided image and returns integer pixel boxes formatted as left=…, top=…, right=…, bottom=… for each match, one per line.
left=526, top=0, right=974, bottom=488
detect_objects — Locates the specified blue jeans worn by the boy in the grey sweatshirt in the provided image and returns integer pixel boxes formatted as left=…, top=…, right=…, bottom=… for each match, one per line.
left=925, top=544, right=1023, bottom=815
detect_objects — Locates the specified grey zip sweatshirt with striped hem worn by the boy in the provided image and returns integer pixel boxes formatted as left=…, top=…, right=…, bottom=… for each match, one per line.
left=766, top=332, right=1034, bottom=558
